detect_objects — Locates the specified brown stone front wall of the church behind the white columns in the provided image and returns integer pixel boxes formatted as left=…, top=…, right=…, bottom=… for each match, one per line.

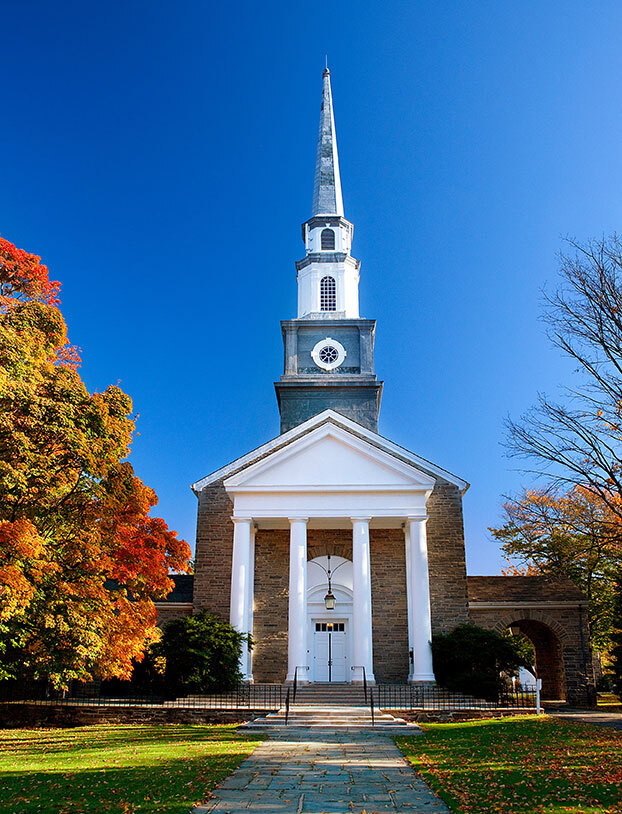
left=188, top=481, right=468, bottom=683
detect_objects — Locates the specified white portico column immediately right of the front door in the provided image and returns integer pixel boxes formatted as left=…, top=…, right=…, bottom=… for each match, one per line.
left=351, top=517, right=375, bottom=682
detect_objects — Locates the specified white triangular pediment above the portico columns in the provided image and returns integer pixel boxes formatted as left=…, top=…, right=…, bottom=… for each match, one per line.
left=225, top=422, right=435, bottom=491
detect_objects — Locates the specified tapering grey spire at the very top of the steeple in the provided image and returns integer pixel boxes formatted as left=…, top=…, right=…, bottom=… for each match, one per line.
left=312, top=68, right=343, bottom=217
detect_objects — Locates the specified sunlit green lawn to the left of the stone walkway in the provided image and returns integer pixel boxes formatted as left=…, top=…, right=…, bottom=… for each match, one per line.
left=0, top=725, right=262, bottom=814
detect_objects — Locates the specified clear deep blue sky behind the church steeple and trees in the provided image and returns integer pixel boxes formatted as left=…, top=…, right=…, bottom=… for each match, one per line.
left=0, top=0, right=622, bottom=573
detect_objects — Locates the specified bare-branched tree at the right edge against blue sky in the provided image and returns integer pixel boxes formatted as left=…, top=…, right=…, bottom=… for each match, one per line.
left=507, top=234, right=622, bottom=518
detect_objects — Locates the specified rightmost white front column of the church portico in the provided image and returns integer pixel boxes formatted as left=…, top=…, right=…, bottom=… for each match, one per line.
left=408, top=517, right=435, bottom=681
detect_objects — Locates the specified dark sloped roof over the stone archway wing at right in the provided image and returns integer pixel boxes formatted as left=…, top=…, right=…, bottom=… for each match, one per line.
left=467, top=576, right=587, bottom=602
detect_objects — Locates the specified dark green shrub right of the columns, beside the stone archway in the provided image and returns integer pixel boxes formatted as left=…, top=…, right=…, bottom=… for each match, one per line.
left=432, top=625, right=529, bottom=701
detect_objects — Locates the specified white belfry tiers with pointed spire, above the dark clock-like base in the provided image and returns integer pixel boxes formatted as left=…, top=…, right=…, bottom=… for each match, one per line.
left=296, top=68, right=360, bottom=320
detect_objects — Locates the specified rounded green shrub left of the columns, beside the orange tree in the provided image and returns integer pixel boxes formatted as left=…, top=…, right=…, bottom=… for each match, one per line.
left=153, top=611, right=251, bottom=695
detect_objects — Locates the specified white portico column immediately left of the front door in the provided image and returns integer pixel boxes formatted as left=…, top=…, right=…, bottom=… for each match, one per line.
left=286, top=517, right=308, bottom=681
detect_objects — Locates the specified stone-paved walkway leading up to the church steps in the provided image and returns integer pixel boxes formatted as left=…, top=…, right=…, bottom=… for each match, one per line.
left=193, top=727, right=449, bottom=814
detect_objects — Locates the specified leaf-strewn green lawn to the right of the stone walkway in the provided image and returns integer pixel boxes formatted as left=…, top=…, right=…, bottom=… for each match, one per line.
left=396, top=715, right=622, bottom=814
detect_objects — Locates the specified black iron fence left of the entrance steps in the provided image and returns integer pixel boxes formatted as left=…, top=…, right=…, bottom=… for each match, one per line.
left=0, top=682, right=283, bottom=710
